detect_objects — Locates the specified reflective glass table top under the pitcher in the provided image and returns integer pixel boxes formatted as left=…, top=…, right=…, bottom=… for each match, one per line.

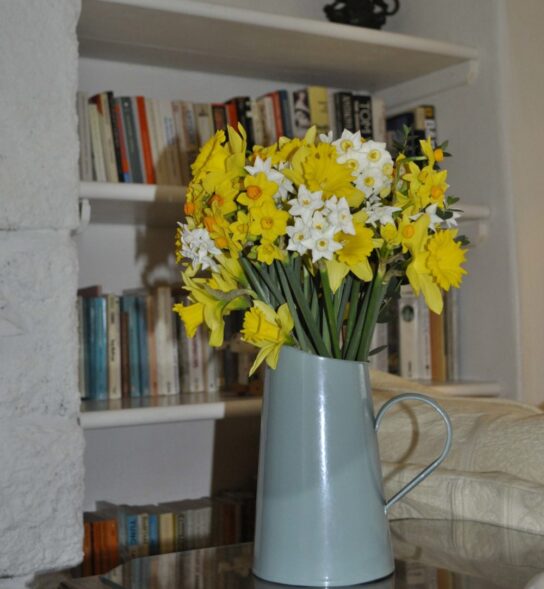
left=63, top=520, right=544, bottom=589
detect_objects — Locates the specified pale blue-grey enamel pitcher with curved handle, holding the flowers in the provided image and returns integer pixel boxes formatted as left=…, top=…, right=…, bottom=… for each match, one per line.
left=253, top=346, right=451, bottom=586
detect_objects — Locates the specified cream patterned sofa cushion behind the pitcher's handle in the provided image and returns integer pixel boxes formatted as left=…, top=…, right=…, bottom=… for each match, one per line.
left=371, top=371, right=544, bottom=533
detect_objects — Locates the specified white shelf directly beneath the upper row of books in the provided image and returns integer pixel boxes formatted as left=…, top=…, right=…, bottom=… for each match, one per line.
left=80, top=182, right=490, bottom=227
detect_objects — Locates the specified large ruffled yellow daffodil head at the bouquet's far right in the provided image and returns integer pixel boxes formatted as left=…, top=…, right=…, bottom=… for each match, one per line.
left=427, top=229, right=467, bottom=291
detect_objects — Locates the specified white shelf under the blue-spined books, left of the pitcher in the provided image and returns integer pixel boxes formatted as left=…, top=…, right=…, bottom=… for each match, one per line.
left=80, top=393, right=262, bottom=429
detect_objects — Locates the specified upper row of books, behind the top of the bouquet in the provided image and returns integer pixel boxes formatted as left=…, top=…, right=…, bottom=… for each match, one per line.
left=77, top=86, right=385, bottom=185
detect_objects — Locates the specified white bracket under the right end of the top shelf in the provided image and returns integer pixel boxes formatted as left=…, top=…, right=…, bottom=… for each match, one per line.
left=378, top=59, right=479, bottom=115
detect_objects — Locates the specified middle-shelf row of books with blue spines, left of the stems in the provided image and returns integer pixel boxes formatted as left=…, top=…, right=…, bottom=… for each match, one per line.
left=78, top=286, right=261, bottom=400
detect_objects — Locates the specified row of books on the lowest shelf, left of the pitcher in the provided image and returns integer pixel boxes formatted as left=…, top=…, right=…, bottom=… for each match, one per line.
left=74, top=491, right=255, bottom=576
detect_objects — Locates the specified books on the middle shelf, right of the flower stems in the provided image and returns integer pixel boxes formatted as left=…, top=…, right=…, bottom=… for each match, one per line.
left=370, top=284, right=460, bottom=383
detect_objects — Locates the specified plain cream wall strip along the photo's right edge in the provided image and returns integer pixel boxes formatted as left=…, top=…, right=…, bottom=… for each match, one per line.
left=501, top=0, right=544, bottom=404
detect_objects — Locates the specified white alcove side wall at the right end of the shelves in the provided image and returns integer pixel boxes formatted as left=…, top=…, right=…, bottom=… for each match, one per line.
left=387, top=0, right=520, bottom=399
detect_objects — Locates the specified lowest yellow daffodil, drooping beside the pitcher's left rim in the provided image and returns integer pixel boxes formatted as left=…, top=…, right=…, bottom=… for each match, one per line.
left=242, top=301, right=293, bottom=376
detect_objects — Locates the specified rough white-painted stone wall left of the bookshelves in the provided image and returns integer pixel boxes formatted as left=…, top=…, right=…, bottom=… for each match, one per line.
left=0, top=0, right=83, bottom=589
